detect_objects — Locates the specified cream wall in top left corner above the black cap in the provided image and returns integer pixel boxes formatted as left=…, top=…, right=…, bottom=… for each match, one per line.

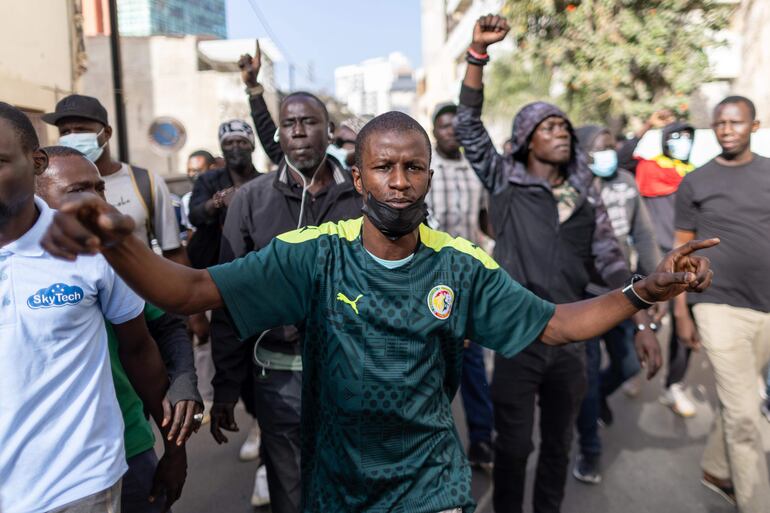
left=0, top=0, right=79, bottom=143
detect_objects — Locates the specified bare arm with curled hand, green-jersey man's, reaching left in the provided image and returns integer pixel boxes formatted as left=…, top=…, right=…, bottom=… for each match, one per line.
left=41, top=194, right=223, bottom=315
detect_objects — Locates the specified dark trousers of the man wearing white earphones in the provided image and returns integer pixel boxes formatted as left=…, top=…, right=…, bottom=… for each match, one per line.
left=254, top=366, right=302, bottom=513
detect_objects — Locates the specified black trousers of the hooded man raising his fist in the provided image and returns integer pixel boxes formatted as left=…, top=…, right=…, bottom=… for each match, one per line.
left=492, top=341, right=587, bottom=513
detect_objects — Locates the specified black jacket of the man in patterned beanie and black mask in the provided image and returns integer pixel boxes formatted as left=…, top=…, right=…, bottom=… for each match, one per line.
left=187, top=168, right=260, bottom=269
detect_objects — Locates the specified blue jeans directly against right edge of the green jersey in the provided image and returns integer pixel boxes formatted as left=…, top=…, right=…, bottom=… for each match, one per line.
left=460, top=342, right=493, bottom=444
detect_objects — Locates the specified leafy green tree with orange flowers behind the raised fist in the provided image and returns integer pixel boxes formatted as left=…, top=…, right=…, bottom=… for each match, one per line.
left=489, top=0, right=734, bottom=124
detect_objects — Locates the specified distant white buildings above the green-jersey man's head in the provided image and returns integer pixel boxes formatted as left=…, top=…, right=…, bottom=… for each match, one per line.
left=334, top=52, right=417, bottom=116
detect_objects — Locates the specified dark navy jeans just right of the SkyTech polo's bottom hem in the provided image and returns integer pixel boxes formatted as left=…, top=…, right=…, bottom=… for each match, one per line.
left=120, top=449, right=166, bottom=513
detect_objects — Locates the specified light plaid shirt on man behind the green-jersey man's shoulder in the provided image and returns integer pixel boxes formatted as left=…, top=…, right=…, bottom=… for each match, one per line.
left=425, top=151, right=486, bottom=246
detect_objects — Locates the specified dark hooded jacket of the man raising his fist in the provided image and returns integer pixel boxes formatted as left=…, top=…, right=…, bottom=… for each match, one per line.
left=455, top=86, right=629, bottom=303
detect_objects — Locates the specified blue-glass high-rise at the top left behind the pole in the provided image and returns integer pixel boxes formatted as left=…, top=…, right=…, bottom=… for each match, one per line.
left=83, top=0, right=227, bottom=39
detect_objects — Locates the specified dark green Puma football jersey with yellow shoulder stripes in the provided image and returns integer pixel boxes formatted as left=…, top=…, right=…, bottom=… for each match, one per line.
left=209, top=218, right=554, bottom=513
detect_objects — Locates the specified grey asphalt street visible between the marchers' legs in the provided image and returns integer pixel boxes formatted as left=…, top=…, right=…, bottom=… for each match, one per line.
left=174, top=346, right=770, bottom=513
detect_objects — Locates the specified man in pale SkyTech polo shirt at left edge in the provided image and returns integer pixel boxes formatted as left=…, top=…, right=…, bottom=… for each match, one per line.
left=0, top=102, right=168, bottom=513
